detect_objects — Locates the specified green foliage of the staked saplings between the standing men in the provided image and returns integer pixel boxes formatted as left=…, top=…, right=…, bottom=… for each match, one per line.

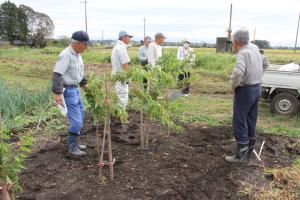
left=86, top=54, right=180, bottom=130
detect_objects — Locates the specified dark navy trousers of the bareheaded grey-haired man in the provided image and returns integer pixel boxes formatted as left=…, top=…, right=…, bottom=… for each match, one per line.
left=233, top=84, right=261, bottom=144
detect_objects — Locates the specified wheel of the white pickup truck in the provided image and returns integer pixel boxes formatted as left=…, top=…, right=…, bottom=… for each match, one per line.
left=272, top=92, right=299, bottom=115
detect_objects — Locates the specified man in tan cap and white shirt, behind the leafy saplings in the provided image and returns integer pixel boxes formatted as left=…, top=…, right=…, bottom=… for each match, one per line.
left=148, top=33, right=166, bottom=67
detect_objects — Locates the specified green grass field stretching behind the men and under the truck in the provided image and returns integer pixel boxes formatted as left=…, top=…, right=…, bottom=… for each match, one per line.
left=0, top=47, right=300, bottom=136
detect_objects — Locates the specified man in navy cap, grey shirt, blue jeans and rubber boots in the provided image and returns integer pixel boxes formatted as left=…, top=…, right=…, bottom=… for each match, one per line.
left=52, top=31, right=90, bottom=156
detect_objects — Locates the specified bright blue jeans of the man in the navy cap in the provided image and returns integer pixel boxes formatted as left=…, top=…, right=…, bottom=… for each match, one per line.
left=64, top=86, right=84, bottom=136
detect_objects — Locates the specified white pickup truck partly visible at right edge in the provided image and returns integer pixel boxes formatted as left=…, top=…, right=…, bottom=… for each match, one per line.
left=262, top=65, right=300, bottom=115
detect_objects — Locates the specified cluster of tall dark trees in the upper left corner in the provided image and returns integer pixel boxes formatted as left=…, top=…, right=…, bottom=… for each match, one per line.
left=0, top=1, right=54, bottom=48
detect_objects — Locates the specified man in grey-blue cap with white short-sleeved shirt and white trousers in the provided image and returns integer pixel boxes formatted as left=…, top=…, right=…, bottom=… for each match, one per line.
left=111, top=31, right=133, bottom=108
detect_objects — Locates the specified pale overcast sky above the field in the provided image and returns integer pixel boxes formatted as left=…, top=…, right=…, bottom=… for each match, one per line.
left=0, top=0, right=300, bottom=46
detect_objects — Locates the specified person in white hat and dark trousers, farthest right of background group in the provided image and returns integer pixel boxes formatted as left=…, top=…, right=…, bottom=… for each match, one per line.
left=177, top=39, right=196, bottom=97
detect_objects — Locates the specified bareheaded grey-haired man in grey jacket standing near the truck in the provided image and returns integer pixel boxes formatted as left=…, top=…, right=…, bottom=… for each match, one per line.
left=225, top=29, right=268, bottom=163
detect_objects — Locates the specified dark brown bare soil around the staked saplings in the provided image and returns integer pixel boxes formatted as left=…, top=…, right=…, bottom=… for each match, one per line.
left=12, top=114, right=296, bottom=200
